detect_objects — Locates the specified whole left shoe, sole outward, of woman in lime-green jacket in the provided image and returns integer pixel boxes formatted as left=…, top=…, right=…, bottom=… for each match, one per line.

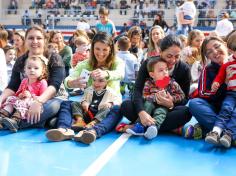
left=46, top=128, right=75, bottom=142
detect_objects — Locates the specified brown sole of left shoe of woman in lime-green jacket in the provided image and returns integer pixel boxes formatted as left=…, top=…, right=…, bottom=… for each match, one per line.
left=46, top=129, right=74, bottom=142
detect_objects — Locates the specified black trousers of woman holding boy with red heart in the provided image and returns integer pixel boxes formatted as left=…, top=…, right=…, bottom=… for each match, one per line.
left=120, top=100, right=192, bottom=131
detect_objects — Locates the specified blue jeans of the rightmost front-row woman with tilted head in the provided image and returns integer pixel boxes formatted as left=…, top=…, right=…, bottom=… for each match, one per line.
left=189, top=98, right=236, bottom=140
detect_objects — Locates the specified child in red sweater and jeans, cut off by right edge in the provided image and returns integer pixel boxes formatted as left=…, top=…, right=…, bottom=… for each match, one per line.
left=205, top=35, right=236, bottom=148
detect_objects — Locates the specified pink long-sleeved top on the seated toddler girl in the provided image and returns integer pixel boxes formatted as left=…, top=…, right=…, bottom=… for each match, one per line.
left=15, top=78, right=48, bottom=96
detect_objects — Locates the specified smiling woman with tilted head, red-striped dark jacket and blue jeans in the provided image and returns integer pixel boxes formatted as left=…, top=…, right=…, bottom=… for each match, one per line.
left=189, top=37, right=236, bottom=146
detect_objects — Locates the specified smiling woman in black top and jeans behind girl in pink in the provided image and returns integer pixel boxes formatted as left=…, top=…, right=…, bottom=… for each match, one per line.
left=0, top=26, right=65, bottom=128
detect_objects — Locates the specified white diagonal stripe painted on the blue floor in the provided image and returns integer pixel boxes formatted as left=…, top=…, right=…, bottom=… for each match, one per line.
left=81, top=133, right=131, bottom=176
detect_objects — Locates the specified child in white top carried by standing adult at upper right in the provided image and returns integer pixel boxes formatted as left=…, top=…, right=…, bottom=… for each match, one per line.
left=179, top=0, right=196, bottom=32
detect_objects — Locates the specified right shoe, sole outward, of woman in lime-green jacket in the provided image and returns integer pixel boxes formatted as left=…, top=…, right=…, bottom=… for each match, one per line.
left=74, top=129, right=97, bottom=144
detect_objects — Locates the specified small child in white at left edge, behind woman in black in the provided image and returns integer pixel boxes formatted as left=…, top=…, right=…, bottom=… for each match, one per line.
left=3, top=45, right=16, bottom=82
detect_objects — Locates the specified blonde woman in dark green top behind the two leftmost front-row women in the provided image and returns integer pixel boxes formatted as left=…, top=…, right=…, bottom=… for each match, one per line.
left=49, top=31, right=73, bottom=76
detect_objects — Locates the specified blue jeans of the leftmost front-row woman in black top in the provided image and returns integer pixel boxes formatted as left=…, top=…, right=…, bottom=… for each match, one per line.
left=19, top=98, right=63, bottom=129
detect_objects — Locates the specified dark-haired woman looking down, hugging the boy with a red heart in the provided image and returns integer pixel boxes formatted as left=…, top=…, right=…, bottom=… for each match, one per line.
left=121, top=35, right=191, bottom=131
